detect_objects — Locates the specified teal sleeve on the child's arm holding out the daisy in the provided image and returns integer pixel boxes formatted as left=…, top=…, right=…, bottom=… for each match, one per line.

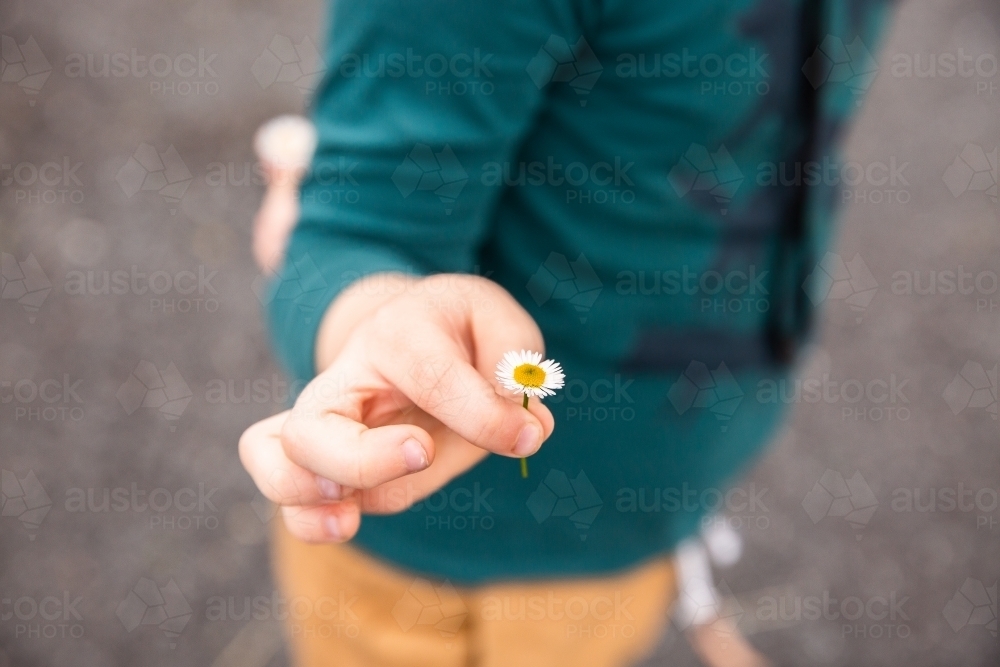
left=267, top=0, right=582, bottom=379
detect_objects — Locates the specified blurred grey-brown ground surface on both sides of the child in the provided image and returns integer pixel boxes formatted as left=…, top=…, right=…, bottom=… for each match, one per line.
left=0, top=0, right=1000, bottom=667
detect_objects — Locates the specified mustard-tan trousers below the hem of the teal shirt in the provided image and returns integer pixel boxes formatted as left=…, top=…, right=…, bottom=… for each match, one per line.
left=273, top=519, right=676, bottom=667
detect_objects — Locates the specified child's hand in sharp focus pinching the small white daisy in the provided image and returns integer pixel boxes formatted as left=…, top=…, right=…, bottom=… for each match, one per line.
left=240, top=274, right=554, bottom=542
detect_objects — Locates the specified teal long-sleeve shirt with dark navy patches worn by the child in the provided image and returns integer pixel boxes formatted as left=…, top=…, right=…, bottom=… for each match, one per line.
left=268, top=0, right=881, bottom=584
